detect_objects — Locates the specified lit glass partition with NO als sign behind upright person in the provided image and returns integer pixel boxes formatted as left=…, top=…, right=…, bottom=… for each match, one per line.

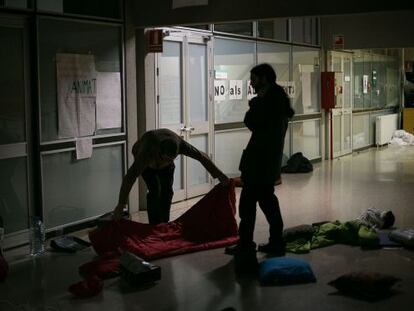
left=213, top=19, right=321, bottom=180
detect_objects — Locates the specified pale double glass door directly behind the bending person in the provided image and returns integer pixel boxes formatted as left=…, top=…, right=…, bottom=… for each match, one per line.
left=156, top=33, right=211, bottom=201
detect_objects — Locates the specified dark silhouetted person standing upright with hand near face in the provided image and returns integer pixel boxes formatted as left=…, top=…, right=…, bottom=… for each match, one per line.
left=226, top=64, right=294, bottom=268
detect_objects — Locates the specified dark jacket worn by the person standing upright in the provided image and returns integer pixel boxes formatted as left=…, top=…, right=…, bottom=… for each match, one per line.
left=239, top=83, right=294, bottom=184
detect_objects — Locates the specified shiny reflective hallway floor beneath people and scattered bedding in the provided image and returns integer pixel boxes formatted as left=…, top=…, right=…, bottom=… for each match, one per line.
left=0, top=147, right=414, bottom=311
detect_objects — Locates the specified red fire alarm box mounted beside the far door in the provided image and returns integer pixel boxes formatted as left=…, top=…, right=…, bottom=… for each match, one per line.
left=321, top=72, right=343, bottom=109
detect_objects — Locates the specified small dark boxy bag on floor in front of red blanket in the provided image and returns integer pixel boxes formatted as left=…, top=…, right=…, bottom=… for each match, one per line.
left=120, top=252, right=161, bottom=286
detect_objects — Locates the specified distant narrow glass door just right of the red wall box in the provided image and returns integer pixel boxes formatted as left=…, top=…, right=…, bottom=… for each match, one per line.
left=328, top=52, right=353, bottom=158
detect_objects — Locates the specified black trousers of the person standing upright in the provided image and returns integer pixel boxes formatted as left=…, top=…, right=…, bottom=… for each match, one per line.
left=239, top=183, right=283, bottom=250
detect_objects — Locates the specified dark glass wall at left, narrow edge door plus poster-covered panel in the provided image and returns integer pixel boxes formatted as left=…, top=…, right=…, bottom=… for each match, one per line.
left=0, top=0, right=126, bottom=248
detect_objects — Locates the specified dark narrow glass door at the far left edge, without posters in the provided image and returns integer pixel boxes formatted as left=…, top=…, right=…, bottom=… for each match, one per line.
left=0, top=16, right=31, bottom=247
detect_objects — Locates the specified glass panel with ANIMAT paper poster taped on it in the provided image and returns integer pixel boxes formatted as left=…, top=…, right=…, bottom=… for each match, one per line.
left=38, top=17, right=125, bottom=229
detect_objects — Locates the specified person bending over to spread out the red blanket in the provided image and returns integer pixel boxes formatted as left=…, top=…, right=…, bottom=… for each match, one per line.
left=113, top=129, right=228, bottom=224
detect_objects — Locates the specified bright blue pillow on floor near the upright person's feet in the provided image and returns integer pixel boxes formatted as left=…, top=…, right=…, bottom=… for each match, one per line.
left=259, top=257, right=316, bottom=285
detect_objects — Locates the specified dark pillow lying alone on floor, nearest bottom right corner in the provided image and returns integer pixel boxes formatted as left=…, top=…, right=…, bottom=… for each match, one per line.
left=328, top=272, right=400, bottom=300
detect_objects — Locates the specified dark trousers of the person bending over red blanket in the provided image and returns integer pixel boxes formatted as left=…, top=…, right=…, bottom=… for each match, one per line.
left=142, top=163, right=175, bottom=224
